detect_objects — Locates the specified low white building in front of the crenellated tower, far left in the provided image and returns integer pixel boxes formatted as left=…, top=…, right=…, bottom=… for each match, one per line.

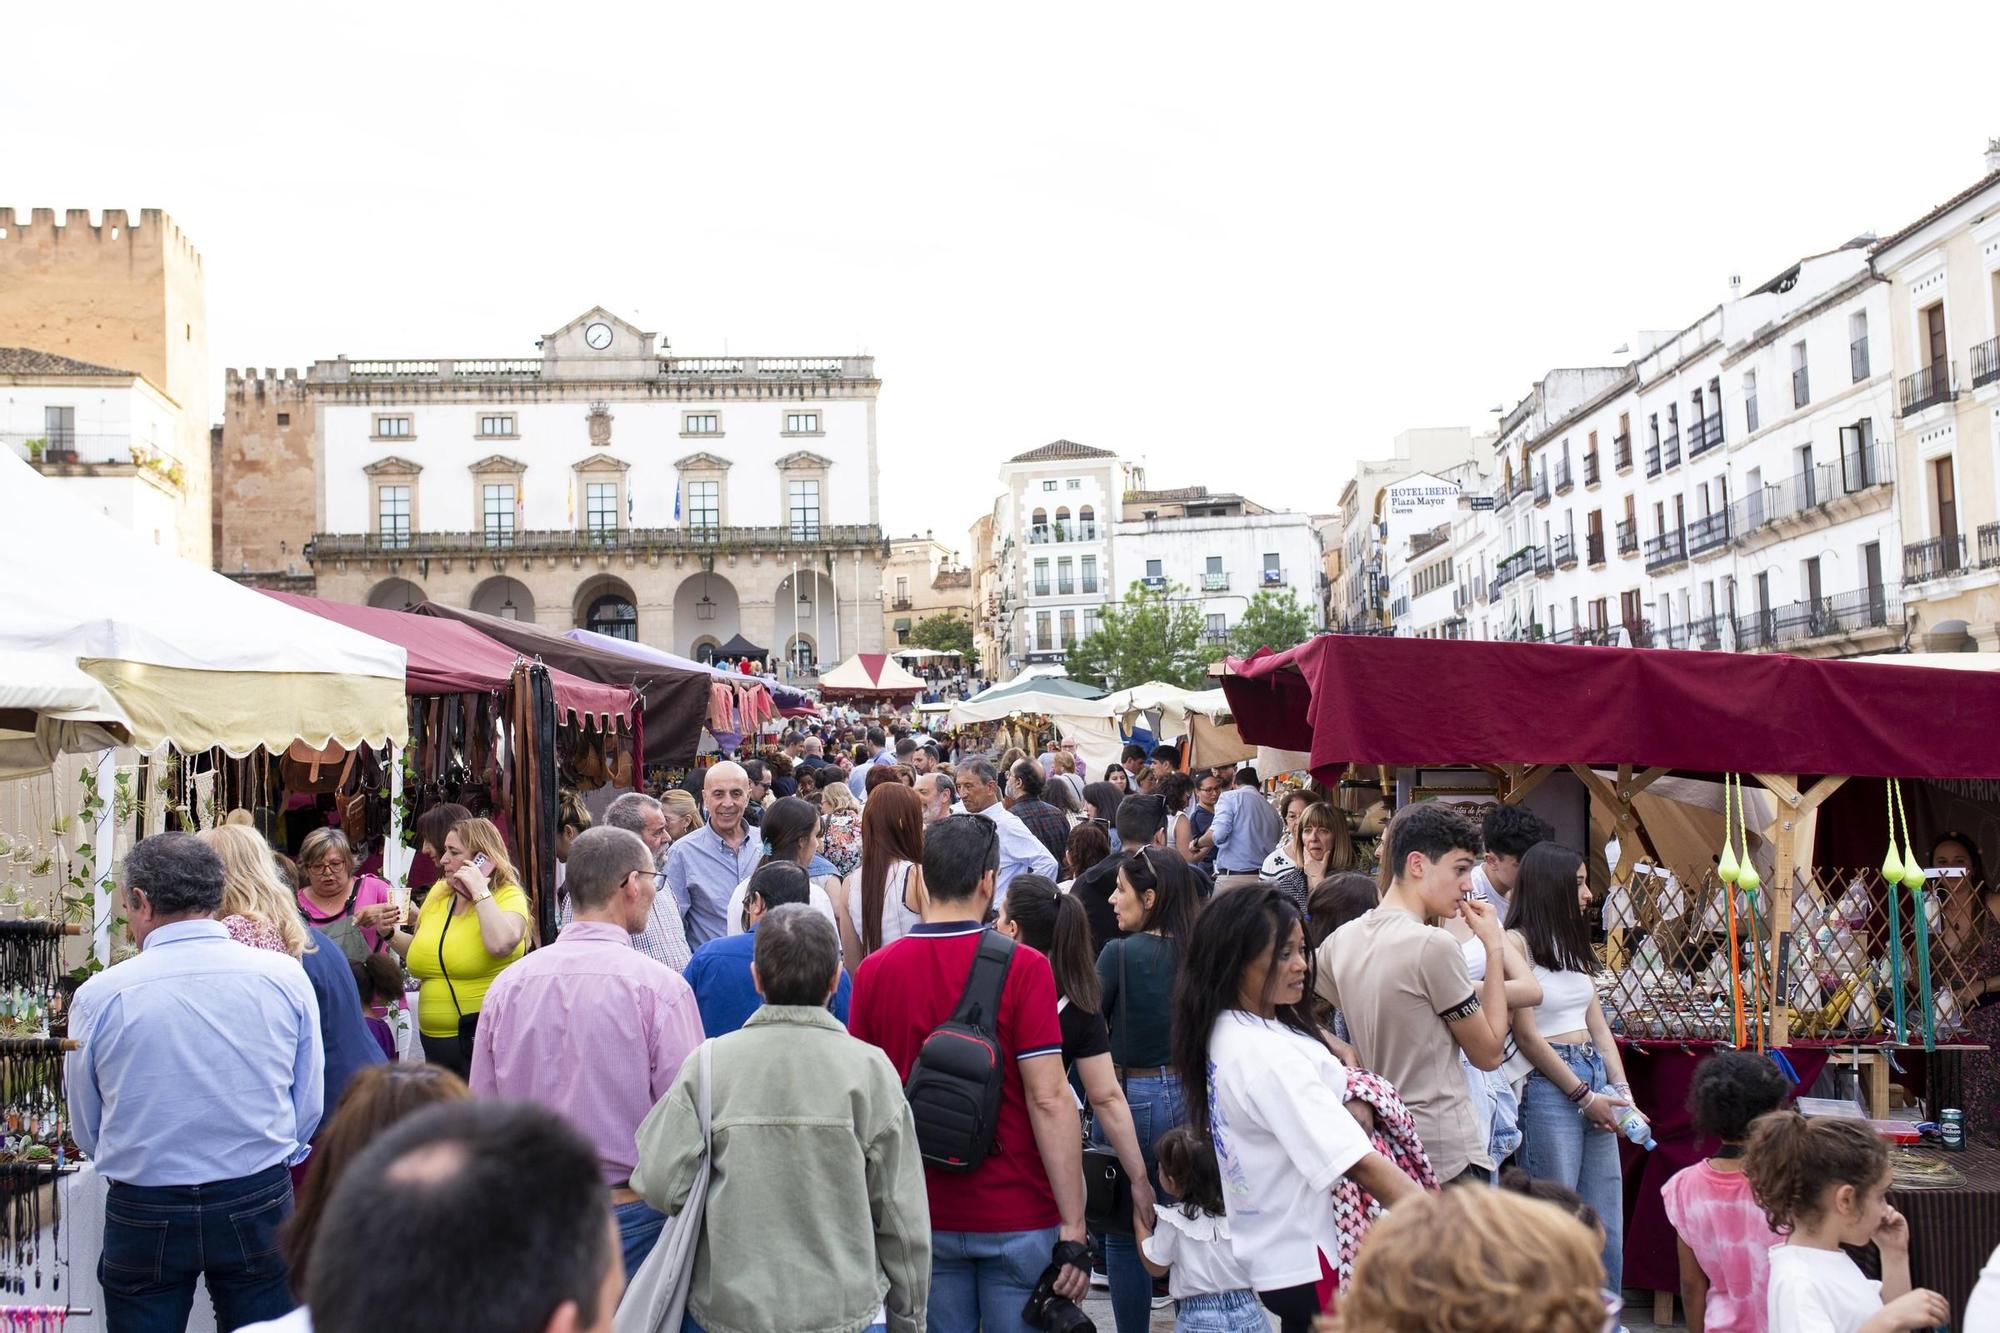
left=0, top=348, right=190, bottom=552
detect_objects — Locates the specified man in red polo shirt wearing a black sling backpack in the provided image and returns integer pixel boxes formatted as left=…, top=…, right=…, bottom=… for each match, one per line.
left=848, top=815, right=1090, bottom=1333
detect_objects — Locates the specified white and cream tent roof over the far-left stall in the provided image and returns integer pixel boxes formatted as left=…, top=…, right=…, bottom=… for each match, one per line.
left=0, top=450, right=408, bottom=755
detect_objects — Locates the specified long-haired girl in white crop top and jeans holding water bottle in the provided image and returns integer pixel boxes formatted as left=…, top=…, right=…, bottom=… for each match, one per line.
left=1506, top=843, right=1632, bottom=1289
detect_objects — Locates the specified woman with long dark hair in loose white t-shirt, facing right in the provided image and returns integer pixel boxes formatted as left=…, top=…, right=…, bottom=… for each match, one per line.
left=1174, top=885, right=1420, bottom=1333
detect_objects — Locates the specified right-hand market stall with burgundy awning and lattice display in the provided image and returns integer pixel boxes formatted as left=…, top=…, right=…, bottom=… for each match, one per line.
left=1224, top=634, right=2000, bottom=1320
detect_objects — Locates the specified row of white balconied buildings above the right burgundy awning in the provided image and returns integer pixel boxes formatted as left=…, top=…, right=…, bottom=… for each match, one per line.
left=1462, top=244, right=1904, bottom=656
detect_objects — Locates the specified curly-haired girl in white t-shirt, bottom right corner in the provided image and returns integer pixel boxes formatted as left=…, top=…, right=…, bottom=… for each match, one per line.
left=1744, top=1111, right=1944, bottom=1333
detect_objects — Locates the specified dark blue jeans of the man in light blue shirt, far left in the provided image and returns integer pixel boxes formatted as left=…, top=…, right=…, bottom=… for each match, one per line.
left=98, top=1163, right=298, bottom=1333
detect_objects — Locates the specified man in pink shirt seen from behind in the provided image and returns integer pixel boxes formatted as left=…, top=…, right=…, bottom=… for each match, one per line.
left=472, top=829, right=702, bottom=1277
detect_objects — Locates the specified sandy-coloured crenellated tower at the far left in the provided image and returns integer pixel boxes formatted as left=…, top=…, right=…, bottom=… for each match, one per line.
left=0, top=208, right=212, bottom=566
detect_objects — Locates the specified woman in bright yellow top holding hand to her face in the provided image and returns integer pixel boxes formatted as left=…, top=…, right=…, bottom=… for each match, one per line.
left=390, top=819, right=528, bottom=1079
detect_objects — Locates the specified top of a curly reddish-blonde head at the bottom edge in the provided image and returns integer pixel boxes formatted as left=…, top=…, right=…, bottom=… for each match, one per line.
left=1320, top=1189, right=1622, bottom=1333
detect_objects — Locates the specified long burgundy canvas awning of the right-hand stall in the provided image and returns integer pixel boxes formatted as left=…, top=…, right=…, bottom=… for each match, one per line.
left=1222, top=634, right=2000, bottom=779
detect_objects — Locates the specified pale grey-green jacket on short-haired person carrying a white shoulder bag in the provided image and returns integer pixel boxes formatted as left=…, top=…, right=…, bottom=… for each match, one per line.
left=632, top=1005, right=930, bottom=1333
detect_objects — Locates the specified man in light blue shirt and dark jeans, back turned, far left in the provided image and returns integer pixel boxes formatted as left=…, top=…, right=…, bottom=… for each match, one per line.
left=64, top=833, right=324, bottom=1333
